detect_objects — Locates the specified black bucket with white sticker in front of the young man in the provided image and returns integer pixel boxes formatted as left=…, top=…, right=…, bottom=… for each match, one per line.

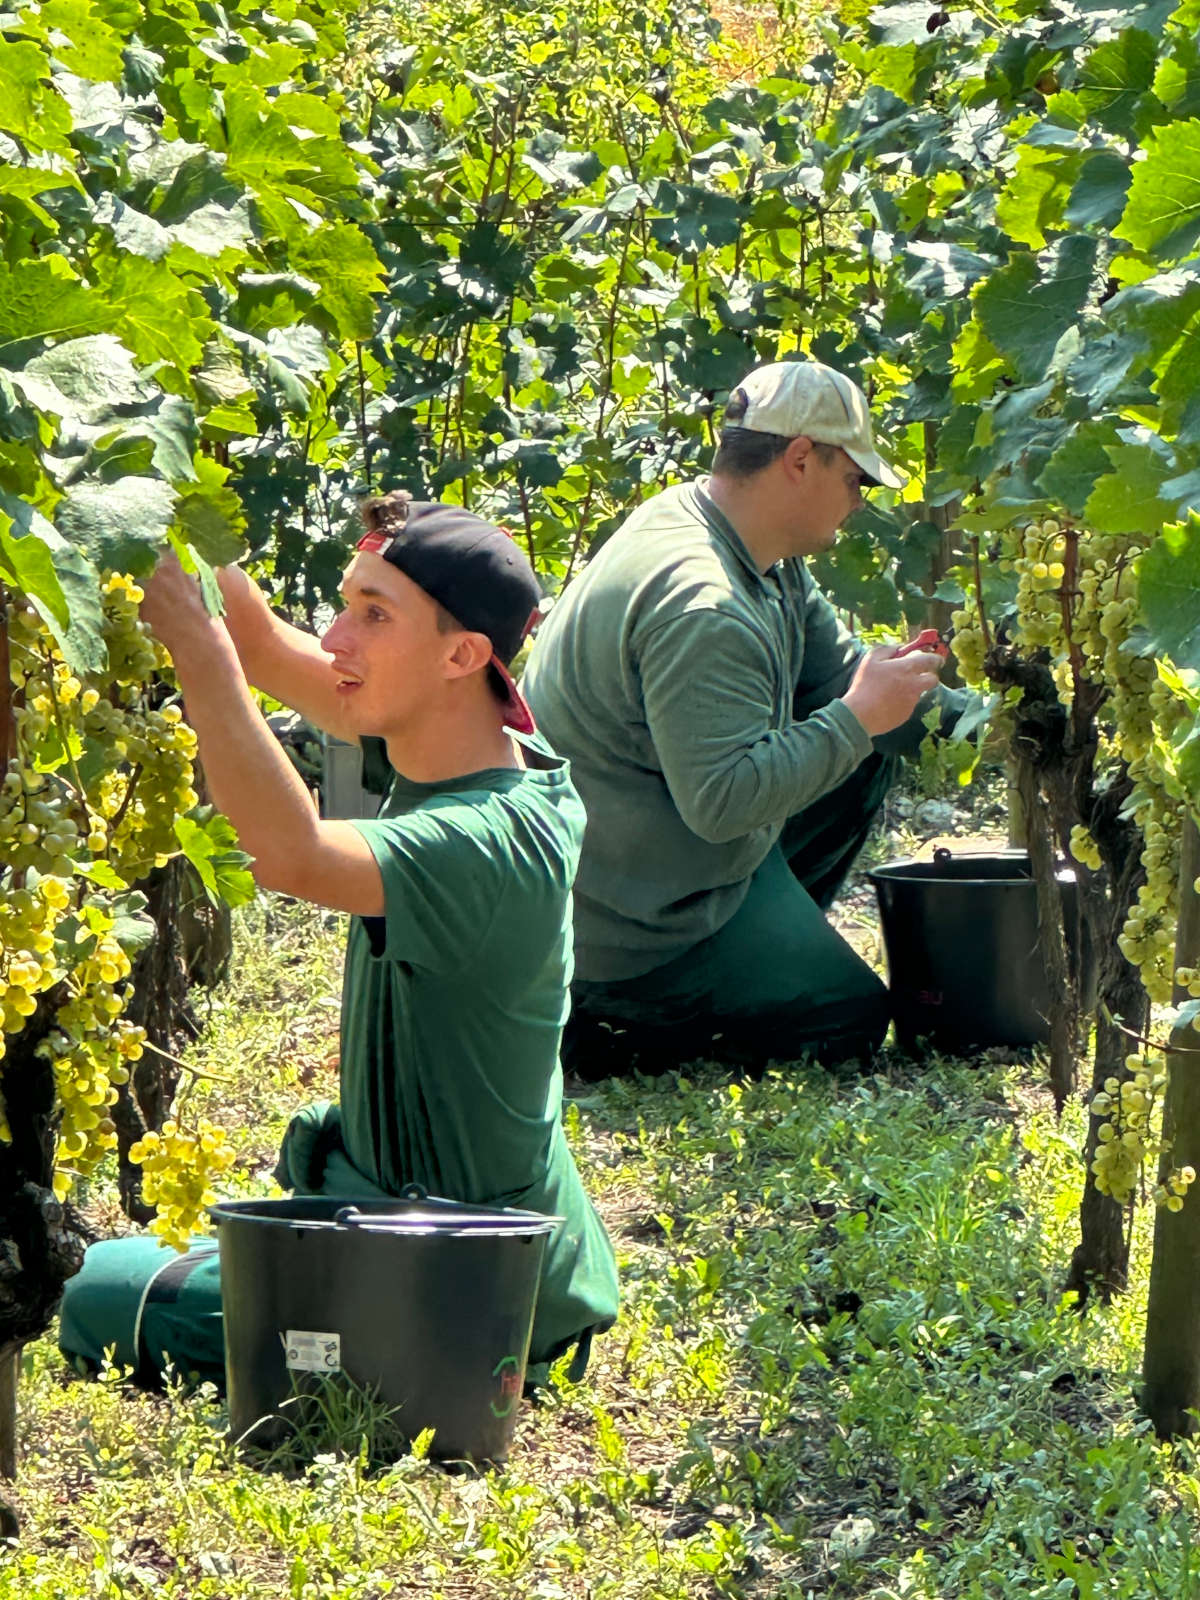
left=213, top=1190, right=560, bottom=1461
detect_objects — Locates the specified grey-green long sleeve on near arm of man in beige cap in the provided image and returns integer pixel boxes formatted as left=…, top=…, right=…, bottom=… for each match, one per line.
left=637, top=611, right=870, bottom=845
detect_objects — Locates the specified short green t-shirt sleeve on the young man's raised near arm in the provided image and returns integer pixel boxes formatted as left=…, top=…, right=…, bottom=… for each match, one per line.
left=352, top=805, right=499, bottom=973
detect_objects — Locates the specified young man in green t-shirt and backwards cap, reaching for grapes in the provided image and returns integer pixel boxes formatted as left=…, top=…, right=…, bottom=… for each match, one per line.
left=64, top=494, right=618, bottom=1371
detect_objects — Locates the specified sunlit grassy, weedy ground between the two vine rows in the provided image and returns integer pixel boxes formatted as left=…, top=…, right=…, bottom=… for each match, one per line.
left=0, top=902, right=1200, bottom=1600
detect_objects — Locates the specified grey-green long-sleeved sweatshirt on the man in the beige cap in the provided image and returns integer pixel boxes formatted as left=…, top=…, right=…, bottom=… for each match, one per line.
left=522, top=478, right=872, bottom=982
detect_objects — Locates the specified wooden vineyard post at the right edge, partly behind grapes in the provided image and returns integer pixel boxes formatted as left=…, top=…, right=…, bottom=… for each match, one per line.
left=1141, top=818, right=1200, bottom=1438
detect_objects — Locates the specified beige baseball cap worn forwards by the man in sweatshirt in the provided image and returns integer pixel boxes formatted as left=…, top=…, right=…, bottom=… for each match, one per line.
left=730, top=362, right=904, bottom=490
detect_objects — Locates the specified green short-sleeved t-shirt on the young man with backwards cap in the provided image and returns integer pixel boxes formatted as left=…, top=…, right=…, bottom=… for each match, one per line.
left=341, top=741, right=618, bottom=1362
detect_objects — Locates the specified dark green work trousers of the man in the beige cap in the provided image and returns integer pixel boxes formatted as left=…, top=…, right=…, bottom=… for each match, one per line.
left=563, top=752, right=899, bottom=1078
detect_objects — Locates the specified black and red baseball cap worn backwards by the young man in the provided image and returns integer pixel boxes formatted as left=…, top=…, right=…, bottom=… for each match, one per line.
left=357, top=490, right=542, bottom=733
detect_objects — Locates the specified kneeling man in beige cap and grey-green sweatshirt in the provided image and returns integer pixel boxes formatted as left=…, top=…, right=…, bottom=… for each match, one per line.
left=522, top=362, right=941, bottom=1075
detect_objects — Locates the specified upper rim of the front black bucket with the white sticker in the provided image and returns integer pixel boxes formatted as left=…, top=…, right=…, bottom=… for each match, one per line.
left=208, top=1195, right=565, bottom=1238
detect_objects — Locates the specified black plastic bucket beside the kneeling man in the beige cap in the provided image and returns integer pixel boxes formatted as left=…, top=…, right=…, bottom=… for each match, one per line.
left=867, top=850, right=1075, bottom=1050
